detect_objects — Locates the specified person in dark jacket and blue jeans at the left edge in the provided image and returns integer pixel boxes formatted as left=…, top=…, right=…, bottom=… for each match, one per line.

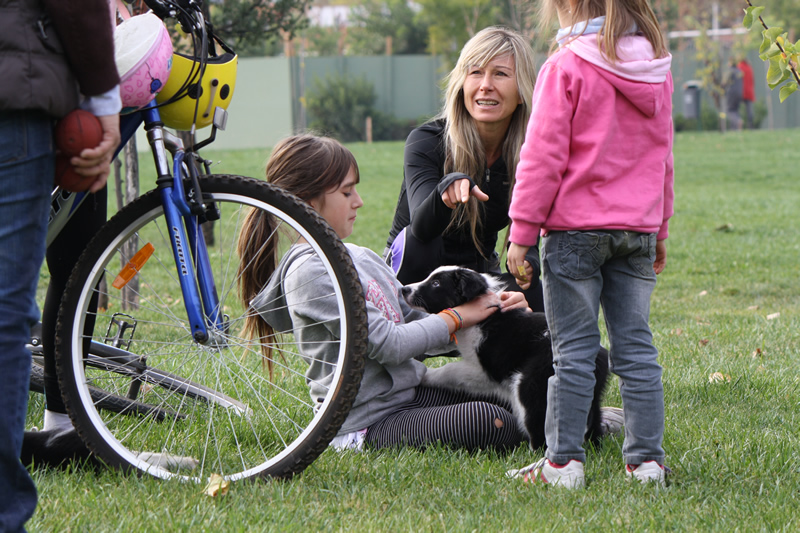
left=0, top=0, right=121, bottom=532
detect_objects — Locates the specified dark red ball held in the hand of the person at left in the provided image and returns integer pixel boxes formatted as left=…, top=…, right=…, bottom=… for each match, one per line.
left=55, top=109, right=103, bottom=192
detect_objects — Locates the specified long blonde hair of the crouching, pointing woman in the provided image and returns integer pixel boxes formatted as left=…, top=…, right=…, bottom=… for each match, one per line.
left=436, top=26, right=536, bottom=257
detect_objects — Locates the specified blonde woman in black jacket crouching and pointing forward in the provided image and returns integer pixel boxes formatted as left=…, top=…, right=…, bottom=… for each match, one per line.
left=384, top=27, right=543, bottom=311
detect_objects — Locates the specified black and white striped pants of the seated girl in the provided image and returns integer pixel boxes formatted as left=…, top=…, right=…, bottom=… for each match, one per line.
left=366, top=386, right=524, bottom=451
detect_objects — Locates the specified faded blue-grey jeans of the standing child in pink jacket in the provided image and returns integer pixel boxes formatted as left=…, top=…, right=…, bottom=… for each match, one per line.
left=542, top=231, right=664, bottom=465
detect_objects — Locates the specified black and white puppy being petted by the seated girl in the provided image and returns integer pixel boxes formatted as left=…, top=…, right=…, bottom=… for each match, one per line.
left=402, top=267, right=608, bottom=448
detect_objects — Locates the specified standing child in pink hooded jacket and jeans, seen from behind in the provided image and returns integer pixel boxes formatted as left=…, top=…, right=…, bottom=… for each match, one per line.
left=508, top=0, right=673, bottom=488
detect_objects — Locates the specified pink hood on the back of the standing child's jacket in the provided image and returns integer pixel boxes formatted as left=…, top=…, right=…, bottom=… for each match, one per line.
left=564, top=34, right=672, bottom=116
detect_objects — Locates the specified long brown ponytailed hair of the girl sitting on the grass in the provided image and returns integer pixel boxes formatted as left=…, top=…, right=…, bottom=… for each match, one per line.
left=237, top=134, right=358, bottom=376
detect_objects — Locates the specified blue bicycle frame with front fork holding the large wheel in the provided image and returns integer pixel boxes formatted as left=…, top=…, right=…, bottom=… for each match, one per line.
left=47, top=101, right=224, bottom=344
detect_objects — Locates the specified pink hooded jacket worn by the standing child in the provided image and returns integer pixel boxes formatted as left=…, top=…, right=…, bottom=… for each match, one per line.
left=509, top=35, right=674, bottom=246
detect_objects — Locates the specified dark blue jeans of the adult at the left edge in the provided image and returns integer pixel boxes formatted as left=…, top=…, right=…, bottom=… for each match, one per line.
left=0, top=111, right=55, bottom=532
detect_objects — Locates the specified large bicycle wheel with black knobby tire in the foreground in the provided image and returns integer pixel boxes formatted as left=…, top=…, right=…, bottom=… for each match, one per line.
left=56, top=175, right=367, bottom=482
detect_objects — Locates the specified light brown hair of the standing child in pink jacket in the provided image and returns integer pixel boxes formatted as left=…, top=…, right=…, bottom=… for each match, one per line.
left=539, top=0, right=669, bottom=63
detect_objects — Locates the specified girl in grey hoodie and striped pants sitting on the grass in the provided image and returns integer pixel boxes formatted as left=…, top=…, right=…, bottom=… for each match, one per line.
left=240, top=135, right=527, bottom=450
